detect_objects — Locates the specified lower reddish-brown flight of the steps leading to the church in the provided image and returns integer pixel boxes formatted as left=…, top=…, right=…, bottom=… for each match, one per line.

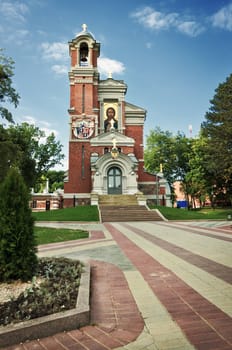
left=99, top=205, right=163, bottom=222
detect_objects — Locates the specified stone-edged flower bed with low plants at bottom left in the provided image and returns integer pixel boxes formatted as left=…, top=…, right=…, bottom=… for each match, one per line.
left=0, top=258, right=90, bottom=347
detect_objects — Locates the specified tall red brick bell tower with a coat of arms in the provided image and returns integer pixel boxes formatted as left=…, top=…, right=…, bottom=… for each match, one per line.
left=65, top=24, right=100, bottom=204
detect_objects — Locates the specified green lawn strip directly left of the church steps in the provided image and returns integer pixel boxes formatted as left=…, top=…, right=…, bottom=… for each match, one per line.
left=33, top=205, right=99, bottom=221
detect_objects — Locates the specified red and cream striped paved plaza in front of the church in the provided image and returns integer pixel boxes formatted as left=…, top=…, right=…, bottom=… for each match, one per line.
left=5, top=221, right=232, bottom=350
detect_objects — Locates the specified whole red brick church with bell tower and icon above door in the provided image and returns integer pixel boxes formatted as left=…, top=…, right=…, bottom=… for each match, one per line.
left=63, top=25, right=170, bottom=207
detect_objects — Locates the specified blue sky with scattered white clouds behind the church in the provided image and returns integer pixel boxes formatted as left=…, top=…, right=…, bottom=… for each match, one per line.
left=0, top=0, right=232, bottom=170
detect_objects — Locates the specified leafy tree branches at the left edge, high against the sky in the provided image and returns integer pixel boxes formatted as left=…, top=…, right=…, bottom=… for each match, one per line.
left=0, top=49, right=20, bottom=123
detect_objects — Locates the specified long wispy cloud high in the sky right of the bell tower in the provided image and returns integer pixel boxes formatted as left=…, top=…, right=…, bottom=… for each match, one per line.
left=131, top=6, right=204, bottom=37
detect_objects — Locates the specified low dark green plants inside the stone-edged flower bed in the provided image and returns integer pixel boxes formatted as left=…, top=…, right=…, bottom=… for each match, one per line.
left=0, top=258, right=82, bottom=325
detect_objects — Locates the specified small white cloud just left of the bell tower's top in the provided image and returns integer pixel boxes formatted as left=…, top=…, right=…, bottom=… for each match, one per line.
left=41, top=42, right=69, bottom=61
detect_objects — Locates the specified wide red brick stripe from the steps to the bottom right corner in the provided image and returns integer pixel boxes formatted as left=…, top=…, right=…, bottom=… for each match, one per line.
left=105, top=224, right=232, bottom=350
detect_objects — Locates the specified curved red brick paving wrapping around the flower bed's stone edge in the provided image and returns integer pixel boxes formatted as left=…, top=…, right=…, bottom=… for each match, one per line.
left=1, top=261, right=144, bottom=350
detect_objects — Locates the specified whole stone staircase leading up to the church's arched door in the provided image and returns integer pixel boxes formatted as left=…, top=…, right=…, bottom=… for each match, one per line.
left=99, top=195, right=163, bottom=222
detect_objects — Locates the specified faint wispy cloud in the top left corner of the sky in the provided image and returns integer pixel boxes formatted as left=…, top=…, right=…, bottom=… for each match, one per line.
left=0, top=1, right=29, bottom=22
